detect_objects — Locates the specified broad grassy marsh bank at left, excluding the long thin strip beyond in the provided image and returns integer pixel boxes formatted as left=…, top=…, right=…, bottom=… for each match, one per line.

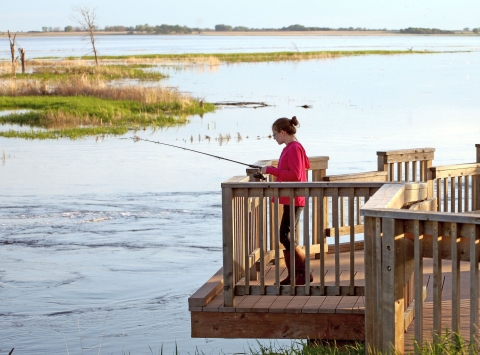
left=0, top=56, right=214, bottom=139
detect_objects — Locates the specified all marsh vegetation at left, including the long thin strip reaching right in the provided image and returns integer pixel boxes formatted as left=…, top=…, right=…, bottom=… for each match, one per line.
left=0, top=50, right=436, bottom=139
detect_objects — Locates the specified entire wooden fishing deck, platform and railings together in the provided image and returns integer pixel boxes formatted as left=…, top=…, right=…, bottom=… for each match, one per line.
left=189, top=144, right=480, bottom=354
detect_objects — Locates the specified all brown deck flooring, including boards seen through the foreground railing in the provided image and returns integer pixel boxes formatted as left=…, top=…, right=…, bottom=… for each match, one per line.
left=189, top=250, right=476, bottom=350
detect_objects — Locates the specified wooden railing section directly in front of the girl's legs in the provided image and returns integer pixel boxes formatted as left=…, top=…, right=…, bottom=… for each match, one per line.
left=222, top=177, right=390, bottom=307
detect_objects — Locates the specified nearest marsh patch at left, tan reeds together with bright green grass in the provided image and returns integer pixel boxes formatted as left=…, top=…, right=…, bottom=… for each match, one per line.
left=0, top=78, right=214, bottom=139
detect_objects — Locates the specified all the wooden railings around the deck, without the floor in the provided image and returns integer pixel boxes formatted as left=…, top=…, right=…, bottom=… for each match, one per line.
left=222, top=144, right=480, bottom=353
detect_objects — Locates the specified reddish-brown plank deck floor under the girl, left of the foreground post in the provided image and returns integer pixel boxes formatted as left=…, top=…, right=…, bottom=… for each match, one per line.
left=189, top=251, right=365, bottom=341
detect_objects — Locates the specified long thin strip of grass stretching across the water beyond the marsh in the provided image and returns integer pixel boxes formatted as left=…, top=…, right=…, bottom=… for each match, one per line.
left=76, top=50, right=438, bottom=63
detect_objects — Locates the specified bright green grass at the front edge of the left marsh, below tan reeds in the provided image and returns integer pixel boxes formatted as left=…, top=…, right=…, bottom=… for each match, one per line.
left=0, top=96, right=214, bottom=139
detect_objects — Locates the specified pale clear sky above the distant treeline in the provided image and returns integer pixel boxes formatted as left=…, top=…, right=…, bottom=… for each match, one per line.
left=0, top=0, right=480, bottom=32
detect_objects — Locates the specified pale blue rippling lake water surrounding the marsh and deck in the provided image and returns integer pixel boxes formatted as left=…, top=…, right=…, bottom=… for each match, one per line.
left=0, top=36, right=480, bottom=354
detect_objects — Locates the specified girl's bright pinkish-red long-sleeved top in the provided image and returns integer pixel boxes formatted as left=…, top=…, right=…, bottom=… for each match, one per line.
left=266, top=141, right=310, bottom=206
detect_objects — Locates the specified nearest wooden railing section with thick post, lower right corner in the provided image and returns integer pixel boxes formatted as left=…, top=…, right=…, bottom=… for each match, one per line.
left=361, top=185, right=480, bottom=353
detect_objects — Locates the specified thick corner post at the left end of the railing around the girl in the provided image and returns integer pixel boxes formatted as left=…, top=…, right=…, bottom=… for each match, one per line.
left=222, top=186, right=235, bottom=307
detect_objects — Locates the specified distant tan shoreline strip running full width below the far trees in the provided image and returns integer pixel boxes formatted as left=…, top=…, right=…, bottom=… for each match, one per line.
left=0, top=30, right=479, bottom=38
